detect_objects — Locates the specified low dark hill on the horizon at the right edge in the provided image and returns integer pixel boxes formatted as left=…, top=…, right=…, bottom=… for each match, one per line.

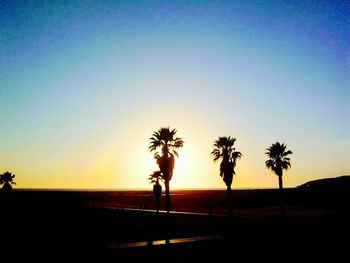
left=297, top=175, right=350, bottom=191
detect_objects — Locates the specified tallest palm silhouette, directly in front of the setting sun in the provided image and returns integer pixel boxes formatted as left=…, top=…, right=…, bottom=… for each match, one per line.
left=148, top=127, right=184, bottom=215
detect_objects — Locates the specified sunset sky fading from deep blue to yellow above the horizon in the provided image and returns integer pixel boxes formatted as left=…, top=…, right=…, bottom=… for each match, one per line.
left=0, top=0, right=350, bottom=189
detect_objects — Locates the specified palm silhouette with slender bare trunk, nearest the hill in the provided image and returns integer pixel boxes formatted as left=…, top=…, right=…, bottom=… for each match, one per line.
left=265, top=142, right=293, bottom=192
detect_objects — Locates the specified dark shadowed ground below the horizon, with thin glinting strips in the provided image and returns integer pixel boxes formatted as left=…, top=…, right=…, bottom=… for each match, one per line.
left=0, top=189, right=350, bottom=262
